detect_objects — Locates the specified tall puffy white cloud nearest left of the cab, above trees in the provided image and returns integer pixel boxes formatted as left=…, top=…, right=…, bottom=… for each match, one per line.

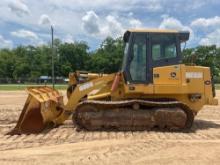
left=82, top=11, right=100, bottom=34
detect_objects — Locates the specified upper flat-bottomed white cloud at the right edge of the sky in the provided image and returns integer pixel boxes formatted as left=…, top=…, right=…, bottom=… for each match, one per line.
left=191, top=16, right=220, bottom=27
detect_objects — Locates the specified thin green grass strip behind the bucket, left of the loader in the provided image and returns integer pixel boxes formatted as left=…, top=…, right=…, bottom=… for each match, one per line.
left=0, top=84, right=68, bottom=91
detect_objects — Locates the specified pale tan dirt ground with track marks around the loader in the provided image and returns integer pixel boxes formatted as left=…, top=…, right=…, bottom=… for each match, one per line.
left=0, top=91, right=220, bottom=165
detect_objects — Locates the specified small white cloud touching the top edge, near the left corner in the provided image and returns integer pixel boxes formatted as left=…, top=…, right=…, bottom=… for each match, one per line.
left=8, top=0, right=30, bottom=17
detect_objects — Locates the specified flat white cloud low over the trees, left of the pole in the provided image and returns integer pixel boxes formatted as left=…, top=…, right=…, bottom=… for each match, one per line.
left=11, top=29, right=39, bottom=40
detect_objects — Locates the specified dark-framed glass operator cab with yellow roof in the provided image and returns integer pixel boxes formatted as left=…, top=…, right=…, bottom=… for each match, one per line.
left=122, top=29, right=189, bottom=84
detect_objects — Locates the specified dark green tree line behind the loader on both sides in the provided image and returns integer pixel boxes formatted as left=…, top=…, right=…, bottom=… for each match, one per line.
left=0, top=37, right=220, bottom=83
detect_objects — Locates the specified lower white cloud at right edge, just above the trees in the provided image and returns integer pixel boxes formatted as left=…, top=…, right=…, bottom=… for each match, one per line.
left=199, top=29, right=220, bottom=47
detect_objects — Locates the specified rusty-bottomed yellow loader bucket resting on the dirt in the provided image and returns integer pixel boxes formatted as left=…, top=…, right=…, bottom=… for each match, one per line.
left=7, top=86, right=63, bottom=135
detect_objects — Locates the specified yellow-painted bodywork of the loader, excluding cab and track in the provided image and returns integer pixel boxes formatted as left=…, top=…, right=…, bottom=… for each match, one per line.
left=19, top=64, right=217, bottom=124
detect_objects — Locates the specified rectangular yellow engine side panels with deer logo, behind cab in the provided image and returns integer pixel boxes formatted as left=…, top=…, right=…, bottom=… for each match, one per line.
left=153, top=64, right=205, bottom=94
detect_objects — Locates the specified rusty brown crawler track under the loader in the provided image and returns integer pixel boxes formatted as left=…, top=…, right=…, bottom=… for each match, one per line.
left=72, top=100, right=194, bottom=131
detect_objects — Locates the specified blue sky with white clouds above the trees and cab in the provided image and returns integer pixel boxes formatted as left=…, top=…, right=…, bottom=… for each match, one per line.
left=0, top=0, right=220, bottom=50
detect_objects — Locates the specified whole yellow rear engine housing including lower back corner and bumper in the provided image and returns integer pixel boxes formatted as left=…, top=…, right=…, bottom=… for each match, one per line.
left=153, top=64, right=217, bottom=111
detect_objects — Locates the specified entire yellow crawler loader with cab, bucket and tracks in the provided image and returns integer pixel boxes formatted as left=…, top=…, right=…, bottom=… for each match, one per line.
left=9, top=29, right=218, bottom=135
